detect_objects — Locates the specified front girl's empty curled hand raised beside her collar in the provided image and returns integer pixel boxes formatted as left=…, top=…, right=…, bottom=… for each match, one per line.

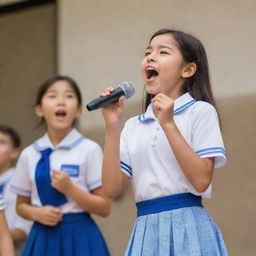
left=152, top=93, right=174, bottom=128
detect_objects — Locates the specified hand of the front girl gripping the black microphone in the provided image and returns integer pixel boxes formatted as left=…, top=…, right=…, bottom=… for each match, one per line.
left=100, top=87, right=125, bottom=125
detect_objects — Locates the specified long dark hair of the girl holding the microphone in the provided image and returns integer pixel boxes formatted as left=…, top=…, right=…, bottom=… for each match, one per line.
left=144, top=29, right=217, bottom=111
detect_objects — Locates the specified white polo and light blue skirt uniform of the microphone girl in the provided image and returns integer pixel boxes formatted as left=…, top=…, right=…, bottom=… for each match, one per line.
left=120, top=93, right=228, bottom=256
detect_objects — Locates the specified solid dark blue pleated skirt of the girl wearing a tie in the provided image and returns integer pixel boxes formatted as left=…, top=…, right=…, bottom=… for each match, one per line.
left=22, top=213, right=110, bottom=256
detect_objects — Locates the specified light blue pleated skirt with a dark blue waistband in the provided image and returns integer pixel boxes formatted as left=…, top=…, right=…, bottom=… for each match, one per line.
left=125, top=193, right=228, bottom=256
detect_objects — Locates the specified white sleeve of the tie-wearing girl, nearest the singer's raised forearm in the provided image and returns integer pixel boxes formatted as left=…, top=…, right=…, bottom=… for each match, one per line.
left=86, top=143, right=103, bottom=191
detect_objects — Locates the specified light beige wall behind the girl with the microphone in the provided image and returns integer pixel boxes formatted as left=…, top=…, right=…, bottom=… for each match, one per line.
left=58, top=0, right=256, bottom=256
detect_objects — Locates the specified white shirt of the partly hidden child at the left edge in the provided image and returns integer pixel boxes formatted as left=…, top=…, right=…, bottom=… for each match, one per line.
left=0, top=168, right=32, bottom=234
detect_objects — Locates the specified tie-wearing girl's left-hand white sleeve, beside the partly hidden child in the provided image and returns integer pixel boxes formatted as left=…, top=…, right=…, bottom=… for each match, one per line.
left=10, top=151, right=31, bottom=197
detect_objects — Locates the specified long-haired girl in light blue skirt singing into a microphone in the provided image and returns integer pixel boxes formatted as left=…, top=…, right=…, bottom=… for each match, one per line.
left=101, top=29, right=227, bottom=256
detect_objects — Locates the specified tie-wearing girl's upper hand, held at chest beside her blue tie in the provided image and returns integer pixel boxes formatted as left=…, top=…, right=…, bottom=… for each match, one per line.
left=51, top=169, right=73, bottom=194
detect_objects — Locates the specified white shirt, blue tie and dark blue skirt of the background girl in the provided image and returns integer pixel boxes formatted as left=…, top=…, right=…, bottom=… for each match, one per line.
left=11, top=129, right=109, bottom=256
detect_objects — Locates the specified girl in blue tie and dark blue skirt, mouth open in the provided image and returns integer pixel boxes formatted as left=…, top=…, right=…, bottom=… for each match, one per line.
left=12, top=76, right=110, bottom=256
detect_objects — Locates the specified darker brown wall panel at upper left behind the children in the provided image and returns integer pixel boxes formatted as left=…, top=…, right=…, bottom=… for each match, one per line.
left=0, top=4, right=56, bottom=146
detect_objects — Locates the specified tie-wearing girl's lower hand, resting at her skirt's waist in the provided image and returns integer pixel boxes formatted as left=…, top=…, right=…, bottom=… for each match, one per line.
left=35, top=205, right=63, bottom=226
